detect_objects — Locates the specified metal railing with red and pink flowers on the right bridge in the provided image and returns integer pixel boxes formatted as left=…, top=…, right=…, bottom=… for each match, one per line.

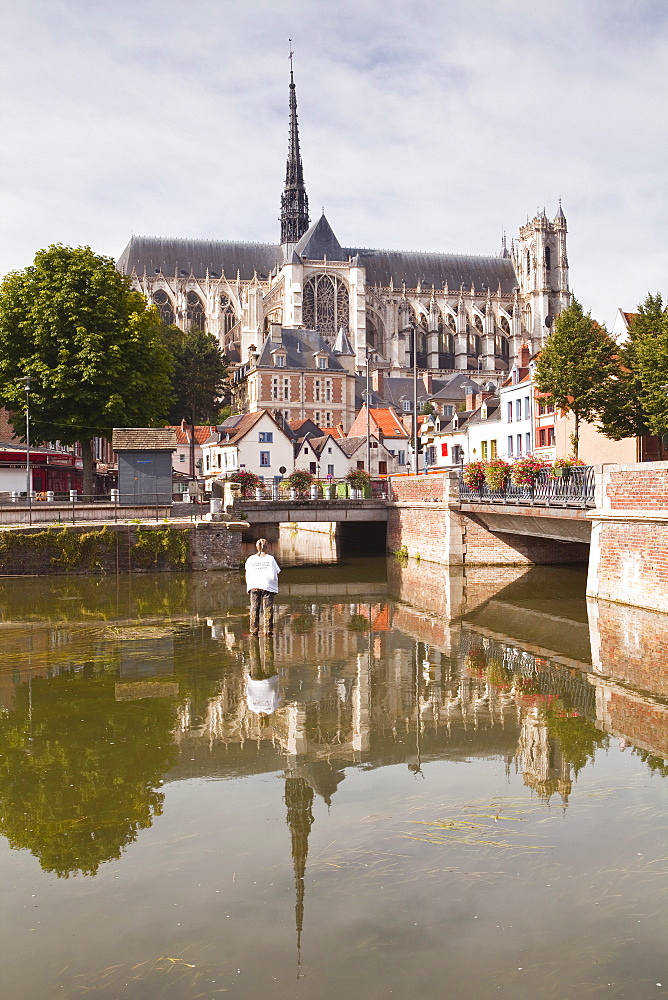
left=459, top=465, right=596, bottom=509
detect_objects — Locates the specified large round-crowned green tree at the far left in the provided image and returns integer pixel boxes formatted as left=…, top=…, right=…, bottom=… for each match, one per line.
left=0, top=245, right=172, bottom=494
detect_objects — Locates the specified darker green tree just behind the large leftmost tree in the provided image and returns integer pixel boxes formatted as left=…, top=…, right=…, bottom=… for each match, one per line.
left=171, top=327, right=227, bottom=425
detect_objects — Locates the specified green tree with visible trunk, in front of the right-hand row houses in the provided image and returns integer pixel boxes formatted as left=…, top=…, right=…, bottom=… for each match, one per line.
left=536, top=299, right=619, bottom=457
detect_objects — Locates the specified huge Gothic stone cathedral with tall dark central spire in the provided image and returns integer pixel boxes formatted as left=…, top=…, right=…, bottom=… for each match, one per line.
left=118, top=72, right=570, bottom=372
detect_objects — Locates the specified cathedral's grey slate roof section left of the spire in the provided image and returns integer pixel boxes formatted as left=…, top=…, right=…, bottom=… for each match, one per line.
left=116, top=236, right=282, bottom=281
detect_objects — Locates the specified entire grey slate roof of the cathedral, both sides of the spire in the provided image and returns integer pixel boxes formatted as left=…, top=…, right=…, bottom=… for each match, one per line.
left=116, top=228, right=518, bottom=294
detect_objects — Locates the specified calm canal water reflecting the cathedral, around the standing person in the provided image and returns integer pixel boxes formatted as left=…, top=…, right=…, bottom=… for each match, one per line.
left=0, top=537, right=668, bottom=1000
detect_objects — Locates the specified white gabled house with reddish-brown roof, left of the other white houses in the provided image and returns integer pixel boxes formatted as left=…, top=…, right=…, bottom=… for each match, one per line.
left=202, top=410, right=294, bottom=480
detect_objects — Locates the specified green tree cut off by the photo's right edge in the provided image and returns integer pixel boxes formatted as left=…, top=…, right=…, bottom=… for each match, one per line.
left=600, top=295, right=668, bottom=441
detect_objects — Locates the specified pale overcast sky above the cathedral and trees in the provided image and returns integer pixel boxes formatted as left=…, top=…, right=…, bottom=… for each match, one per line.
left=0, top=0, right=668, bottom=324
